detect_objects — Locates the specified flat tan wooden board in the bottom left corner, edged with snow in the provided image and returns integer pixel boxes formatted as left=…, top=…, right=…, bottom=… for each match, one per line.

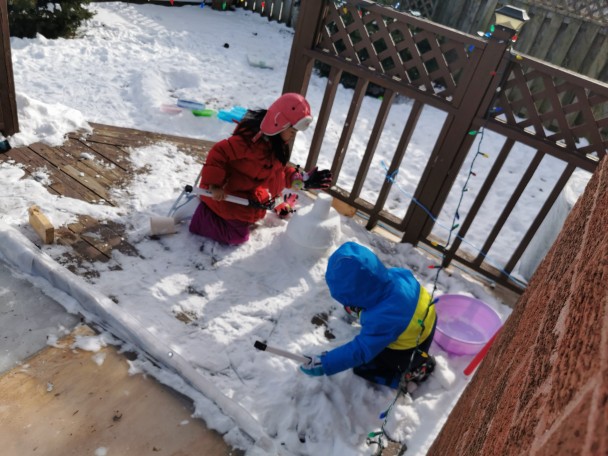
left=0, top=326, right=233, bottom=456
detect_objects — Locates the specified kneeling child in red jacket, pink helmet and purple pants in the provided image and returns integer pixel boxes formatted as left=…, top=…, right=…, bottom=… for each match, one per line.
left=190, top=93, right=331, bottom=245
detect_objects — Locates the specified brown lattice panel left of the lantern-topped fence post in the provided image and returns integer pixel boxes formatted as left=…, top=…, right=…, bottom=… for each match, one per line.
left=317, top=2, right=478, bottom=99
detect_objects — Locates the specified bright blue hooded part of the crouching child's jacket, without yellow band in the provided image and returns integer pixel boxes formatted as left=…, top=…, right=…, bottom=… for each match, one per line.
left=321, top=242, right=435, bottom=375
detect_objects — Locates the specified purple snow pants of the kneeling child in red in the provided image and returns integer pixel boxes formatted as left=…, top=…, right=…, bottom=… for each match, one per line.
left=190, top=201, right=251, bottom=245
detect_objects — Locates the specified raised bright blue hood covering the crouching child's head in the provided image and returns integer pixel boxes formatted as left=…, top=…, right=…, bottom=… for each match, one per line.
left=325, top=242, right=391, bottom=309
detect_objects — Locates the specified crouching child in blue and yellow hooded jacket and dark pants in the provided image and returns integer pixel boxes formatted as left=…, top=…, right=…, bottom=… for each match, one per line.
left=300, top=242, right=437, bottom=388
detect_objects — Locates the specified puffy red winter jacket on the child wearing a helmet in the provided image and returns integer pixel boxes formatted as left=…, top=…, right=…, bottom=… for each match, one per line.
left=199, top=136, right=296, bottom=223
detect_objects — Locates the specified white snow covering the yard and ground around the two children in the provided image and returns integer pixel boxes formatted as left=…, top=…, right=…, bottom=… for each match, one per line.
left=0, top=3, right=586, bottom=456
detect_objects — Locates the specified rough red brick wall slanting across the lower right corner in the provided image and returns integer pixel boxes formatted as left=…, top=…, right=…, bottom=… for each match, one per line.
left=428, top=158, right=608, bottom=456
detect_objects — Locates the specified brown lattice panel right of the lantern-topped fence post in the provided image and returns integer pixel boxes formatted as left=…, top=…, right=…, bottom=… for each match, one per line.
left=497, top=60, right=608, bottom=161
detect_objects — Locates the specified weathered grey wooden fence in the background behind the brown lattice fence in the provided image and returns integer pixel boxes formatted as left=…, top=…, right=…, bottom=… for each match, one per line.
left=236, top=0, right=608, bottom=82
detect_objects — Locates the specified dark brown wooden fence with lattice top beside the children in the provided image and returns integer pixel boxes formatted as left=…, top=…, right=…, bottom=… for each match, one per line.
left=283, top=0, right=608, bottom=290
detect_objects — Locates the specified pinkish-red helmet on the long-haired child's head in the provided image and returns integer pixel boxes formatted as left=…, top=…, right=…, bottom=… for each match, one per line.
left=260, top=93, right=312, bottom=136
